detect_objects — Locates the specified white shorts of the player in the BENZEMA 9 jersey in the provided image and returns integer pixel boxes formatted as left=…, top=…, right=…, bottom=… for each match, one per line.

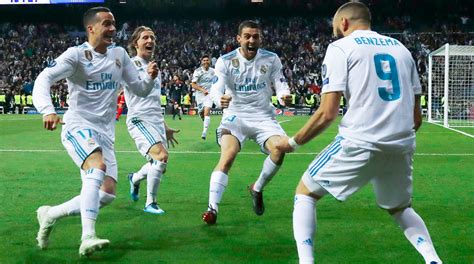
left=302, top=136, right=413, bottom=209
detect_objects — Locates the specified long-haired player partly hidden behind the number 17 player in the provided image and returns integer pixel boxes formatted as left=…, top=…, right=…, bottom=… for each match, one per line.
left=124, top=26, right=178, bottom=214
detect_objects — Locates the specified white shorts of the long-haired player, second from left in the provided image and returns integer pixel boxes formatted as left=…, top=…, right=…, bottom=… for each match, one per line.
left=127, top=117, right=168, bottom=160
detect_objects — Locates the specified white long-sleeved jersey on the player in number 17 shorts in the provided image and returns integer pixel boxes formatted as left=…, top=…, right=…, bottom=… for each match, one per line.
left=33, top=42, right=154, bottom=139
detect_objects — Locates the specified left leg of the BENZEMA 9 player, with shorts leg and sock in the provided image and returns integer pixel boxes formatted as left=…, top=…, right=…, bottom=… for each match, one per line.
left=293, top=136, right=370, bottom=263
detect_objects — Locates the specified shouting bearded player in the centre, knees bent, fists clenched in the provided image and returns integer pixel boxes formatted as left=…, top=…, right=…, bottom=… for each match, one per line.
left=202, top=21, right=291, bottom=225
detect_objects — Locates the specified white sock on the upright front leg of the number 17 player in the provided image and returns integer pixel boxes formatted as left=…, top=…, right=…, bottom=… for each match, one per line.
left=80, top=169, right=105, bottom=239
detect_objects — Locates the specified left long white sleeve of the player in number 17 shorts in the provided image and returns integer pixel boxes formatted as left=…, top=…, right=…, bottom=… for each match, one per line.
left=33, top=48, right=78, bottom=115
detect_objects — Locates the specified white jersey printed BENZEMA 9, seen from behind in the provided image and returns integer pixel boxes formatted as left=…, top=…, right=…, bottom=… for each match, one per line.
left=322, top=30, right=421, bottom=152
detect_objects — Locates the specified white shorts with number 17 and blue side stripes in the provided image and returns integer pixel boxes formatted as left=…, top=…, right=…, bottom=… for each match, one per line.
left=61, top=125, right=118, bottom=181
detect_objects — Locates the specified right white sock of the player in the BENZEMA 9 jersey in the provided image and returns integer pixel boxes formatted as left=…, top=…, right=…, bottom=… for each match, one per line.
left=393, top=207, right=442, bottom=263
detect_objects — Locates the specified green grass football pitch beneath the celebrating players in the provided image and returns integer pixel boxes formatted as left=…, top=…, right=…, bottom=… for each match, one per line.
left=0, top=115, right=474, bottom=264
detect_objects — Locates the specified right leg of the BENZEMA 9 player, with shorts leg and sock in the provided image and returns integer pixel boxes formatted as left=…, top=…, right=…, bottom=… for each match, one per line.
left=372, top=154, right=442, bottom=263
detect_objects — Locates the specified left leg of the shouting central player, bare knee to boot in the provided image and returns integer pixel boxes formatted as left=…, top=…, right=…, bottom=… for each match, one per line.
left=202, top=133, right=240, bottom=225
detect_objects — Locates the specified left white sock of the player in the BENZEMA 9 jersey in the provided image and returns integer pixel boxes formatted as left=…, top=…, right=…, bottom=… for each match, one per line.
left=293, top=194, right=316, bottom=264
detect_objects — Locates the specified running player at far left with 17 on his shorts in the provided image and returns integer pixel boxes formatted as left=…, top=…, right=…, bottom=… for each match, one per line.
left=33, top=7, right=158, bottom=255
